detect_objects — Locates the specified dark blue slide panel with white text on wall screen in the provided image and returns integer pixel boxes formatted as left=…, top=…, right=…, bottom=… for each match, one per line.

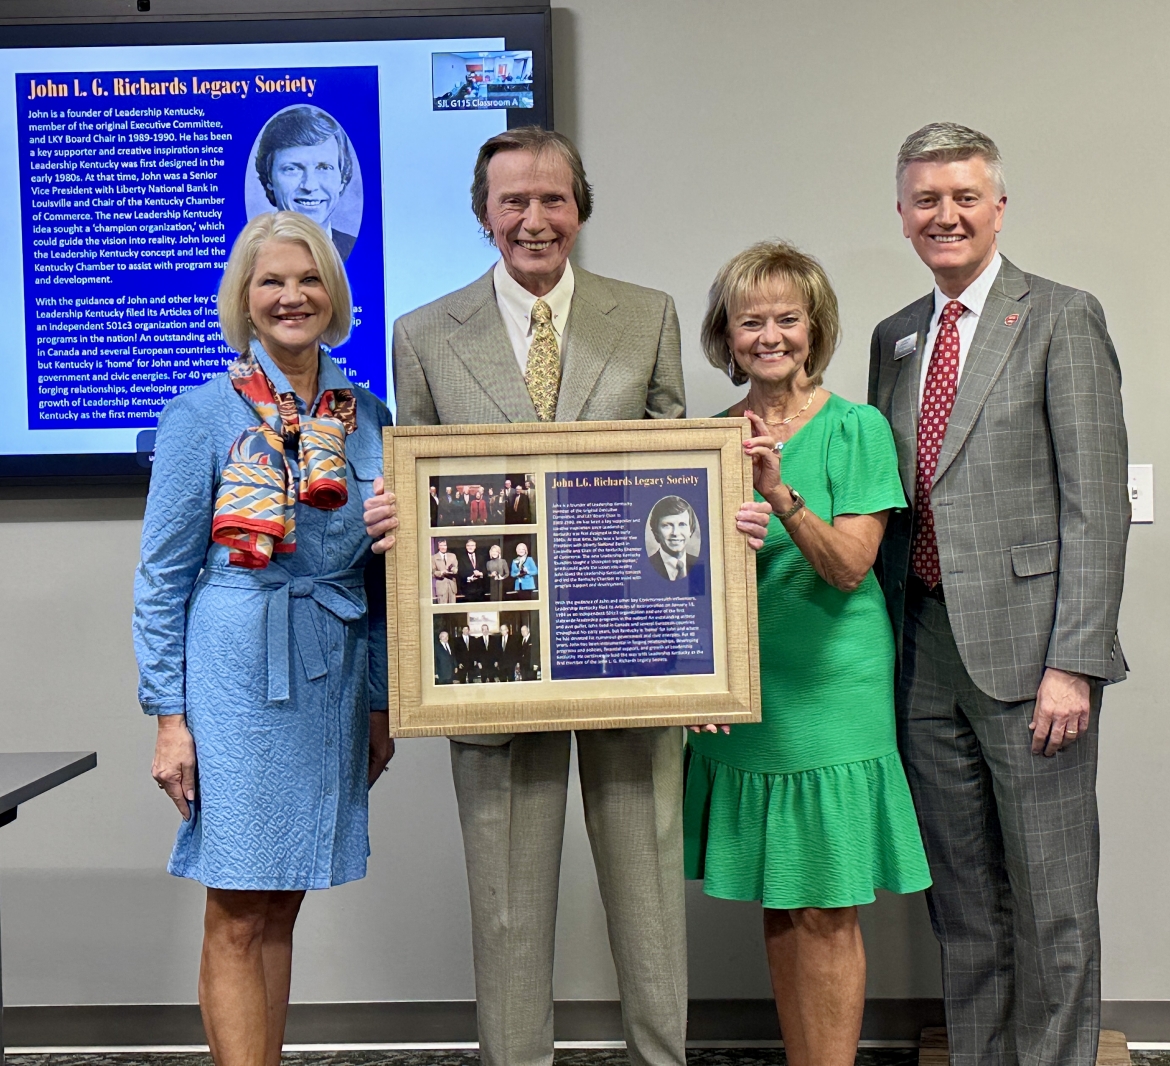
left=16, top=67, right=387, bottom=429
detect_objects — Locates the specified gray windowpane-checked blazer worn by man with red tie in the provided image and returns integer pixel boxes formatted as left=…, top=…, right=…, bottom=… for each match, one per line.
left=869, top=259, right=1129, bottom=702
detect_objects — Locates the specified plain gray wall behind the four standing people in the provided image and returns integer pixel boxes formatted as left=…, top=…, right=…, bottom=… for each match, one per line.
left=0, top=0, right=1170, bottom=1015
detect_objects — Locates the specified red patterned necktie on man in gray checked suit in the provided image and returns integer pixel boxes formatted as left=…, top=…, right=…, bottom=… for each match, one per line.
left=911, top=300, right=966, bottom=589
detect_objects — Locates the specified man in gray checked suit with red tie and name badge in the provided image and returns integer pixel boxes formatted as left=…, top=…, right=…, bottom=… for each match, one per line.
left=869, top=123, right=1129, bottom=1066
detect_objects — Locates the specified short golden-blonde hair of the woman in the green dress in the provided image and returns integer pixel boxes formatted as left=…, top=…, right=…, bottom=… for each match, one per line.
left=701, top=241, right=841, bottom=385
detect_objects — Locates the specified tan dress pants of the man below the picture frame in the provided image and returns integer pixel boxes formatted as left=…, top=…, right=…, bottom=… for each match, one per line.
left=450, top=728, right=687, bottom=1066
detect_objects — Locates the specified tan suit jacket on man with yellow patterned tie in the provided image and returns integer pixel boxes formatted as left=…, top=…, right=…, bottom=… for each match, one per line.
left=393, top=267, right=687, bottom=426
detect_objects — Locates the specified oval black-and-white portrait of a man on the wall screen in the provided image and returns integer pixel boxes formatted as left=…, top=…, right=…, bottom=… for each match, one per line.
left=243, top=104, right=363, bottom=261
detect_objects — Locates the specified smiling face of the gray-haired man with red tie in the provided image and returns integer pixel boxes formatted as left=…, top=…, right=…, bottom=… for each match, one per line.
left=897, top=156, right=1007, bottom=298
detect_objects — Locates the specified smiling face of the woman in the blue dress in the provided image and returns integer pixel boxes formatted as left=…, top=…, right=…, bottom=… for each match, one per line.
left=248, top=241, right=333, bottom=359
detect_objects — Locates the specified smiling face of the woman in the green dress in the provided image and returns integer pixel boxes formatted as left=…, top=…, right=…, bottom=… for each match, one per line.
left=728, top=282, right=810, bottom=388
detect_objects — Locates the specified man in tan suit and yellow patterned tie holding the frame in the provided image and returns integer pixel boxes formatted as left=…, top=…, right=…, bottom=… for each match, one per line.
left=367, top=126, right=687, bottom=1066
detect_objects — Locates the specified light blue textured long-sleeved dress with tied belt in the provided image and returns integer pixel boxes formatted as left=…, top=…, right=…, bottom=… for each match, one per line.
left=133, top=355, right=390, bottom=889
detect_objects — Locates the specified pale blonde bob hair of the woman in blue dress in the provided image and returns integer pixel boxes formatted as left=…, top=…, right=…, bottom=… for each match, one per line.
left=219, top=211, right=353, bottom=353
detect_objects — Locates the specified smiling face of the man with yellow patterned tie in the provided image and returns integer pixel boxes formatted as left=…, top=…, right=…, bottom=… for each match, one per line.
left=487, top=149, right=581, bottom=296
